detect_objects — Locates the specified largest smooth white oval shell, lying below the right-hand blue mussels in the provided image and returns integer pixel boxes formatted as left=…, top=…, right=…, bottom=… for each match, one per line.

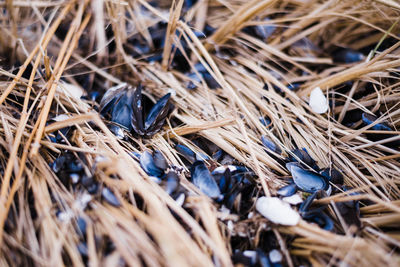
left=256, top=197, right=300, bottom=226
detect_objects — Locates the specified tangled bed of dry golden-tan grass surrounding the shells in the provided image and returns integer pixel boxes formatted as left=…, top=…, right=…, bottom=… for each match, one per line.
left=0, top=0, right=400, bottom=266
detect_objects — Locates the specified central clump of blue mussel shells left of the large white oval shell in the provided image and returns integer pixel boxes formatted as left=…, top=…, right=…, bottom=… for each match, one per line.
left=132, top=144, right=255, bottom=214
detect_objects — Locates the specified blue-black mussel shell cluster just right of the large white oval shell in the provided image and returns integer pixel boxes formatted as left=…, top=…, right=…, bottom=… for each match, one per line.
left=262, top=140, right=361, bottom=231
